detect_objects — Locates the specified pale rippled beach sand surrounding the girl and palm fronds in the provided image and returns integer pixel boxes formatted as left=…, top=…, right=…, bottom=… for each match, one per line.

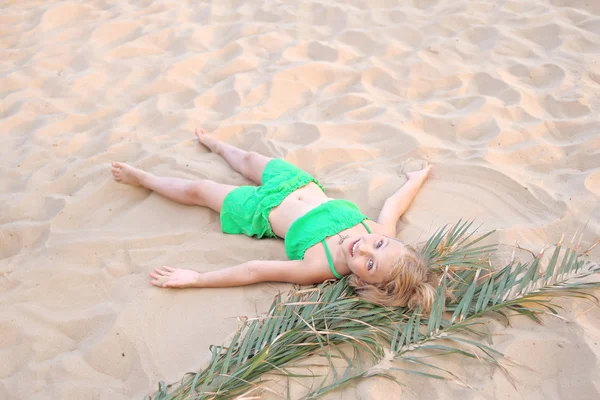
left=0, top=0, right=600, bottom=399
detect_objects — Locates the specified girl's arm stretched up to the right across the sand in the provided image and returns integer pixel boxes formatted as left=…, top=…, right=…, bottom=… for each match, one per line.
left=377, top=165, right=432, bottom=236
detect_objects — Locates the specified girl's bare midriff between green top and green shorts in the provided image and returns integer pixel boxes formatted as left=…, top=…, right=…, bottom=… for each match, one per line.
left=269, top=182, right=332, bottom=238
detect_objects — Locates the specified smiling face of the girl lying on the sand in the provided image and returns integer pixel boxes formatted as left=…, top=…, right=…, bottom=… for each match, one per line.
left=343, top=233, right=404, bottom=283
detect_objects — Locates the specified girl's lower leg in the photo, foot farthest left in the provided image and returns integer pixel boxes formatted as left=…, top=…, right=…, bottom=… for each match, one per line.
left=112, top=162, right=237, bottom=212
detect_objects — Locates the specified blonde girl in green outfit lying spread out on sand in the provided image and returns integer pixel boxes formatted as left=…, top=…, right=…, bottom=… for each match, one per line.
left=112, top=130, right=437, bottom=310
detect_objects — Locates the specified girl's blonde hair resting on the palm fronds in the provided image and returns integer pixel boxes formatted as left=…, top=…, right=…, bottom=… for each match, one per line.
left=348, top=245, right=440, bottom=313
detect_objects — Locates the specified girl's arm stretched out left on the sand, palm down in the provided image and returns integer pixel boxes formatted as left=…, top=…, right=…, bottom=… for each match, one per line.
left=150, top=260, right=330, bottom=288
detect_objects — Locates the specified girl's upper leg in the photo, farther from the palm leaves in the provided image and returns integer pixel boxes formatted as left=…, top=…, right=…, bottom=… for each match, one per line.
left=195, top=129, right=272, bottom=185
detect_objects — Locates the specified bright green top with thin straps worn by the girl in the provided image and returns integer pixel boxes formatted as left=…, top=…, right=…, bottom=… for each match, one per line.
left=284, top=199, right=371, bottom=279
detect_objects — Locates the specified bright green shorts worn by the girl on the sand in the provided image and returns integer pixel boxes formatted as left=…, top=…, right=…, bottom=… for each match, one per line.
left=221, top=158, right=323, bottom=238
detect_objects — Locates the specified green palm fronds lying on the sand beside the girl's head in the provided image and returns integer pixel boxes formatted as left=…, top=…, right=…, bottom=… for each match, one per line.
left=146, top=221, right=600, bottom=400
